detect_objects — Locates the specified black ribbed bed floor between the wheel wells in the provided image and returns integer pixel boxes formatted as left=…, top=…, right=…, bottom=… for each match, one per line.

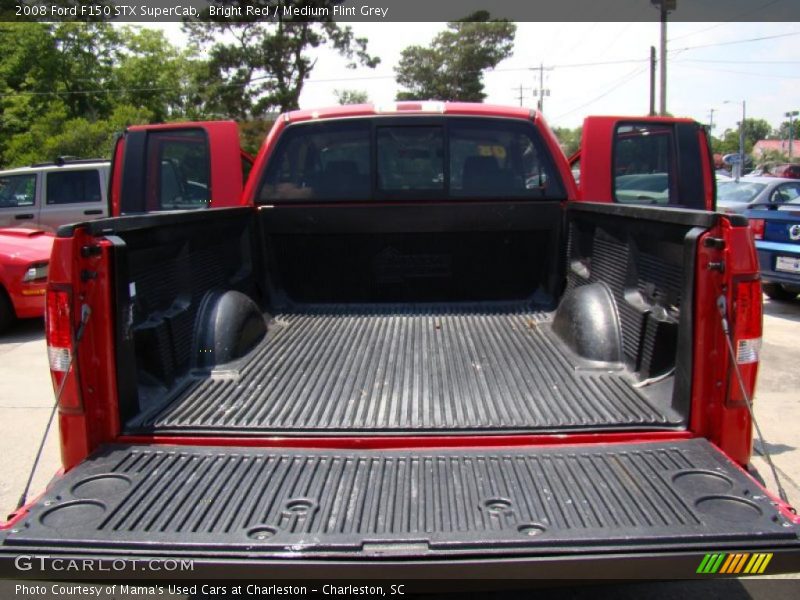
left=127, top=307, right=683, bottom=434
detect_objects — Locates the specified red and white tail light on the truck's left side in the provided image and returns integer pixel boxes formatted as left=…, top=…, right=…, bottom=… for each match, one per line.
left=45, top=286, right=82, bottom=411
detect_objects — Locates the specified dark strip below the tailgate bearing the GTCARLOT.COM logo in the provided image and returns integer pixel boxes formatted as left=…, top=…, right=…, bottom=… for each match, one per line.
left=0, top=545, right=800, bottom=587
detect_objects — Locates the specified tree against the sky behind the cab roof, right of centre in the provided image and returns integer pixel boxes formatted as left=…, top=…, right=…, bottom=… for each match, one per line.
left=395, top=11, right=517, bottom=102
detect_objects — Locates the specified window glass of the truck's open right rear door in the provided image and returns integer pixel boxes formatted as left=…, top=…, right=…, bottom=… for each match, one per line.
left=614, top=123, right=676, bottom=204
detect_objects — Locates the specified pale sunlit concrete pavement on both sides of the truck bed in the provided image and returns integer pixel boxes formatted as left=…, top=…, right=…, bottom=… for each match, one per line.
left=0, top=298, right=800, bottom=515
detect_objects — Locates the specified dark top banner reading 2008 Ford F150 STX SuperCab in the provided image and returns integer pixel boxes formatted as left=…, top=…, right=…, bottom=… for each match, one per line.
left=0, top=0, right=800, bottom=23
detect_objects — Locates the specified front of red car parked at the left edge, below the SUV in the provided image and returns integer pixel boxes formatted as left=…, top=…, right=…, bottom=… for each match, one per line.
left=0, top=228, right=54, bottom=332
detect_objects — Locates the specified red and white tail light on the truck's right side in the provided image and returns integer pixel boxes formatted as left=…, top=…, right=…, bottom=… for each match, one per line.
left=729, top=279, right=761, bottom=403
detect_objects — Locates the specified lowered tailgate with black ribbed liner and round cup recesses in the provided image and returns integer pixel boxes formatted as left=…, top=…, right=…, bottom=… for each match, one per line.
left=0, top=439, right=797, bottom=558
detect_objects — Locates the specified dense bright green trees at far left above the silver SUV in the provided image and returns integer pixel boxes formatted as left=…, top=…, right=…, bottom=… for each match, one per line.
left=0, top=22, right=186, bottom=166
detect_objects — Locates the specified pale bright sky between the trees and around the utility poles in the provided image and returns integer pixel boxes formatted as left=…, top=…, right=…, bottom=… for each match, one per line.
left=155, top=23, right=800, bottom=135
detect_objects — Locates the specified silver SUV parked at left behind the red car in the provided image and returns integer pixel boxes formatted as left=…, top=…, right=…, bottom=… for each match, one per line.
left=0, top=159, right=110, bottom=232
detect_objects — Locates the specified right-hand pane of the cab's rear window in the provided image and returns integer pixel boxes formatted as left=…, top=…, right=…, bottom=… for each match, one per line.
left=450, top=120, right=563, bottom=198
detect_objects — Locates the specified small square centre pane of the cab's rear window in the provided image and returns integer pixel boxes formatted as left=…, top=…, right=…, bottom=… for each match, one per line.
left=377, top=127, right=444, bottom=192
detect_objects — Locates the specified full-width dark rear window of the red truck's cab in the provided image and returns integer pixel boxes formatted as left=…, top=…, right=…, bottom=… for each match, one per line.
left=257, top=117, right=565, bottom=203
